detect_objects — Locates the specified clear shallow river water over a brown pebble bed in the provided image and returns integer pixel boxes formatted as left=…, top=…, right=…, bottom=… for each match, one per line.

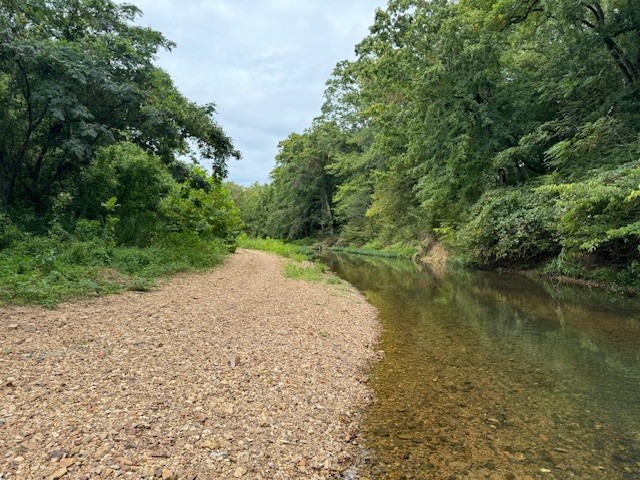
left=323, top=255, right=640, bottom=480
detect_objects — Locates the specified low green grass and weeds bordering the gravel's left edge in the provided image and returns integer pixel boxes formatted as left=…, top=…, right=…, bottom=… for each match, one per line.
left=0, top=234, right=227, bottom=307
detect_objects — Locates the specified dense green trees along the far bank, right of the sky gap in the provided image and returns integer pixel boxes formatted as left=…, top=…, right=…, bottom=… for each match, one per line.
left=235, top=0, right=640, bottom=287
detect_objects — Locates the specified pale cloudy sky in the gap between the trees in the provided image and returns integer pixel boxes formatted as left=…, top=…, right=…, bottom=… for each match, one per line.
left=122, top=0, right=386, bottom=185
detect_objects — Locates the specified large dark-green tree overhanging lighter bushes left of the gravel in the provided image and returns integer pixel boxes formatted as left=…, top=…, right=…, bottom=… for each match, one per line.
left=0, top=0, right=239, bottom=213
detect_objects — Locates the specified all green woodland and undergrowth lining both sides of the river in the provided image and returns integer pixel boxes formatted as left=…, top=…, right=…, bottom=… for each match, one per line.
left=0, top=0, right=640, bottom=304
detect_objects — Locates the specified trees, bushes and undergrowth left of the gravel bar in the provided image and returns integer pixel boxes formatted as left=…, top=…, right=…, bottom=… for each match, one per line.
left=0, top=0, right=241, bottom=303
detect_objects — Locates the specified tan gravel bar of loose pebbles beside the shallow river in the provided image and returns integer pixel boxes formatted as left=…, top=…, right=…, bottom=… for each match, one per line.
left=0, top=251, right=378, bottom=480
